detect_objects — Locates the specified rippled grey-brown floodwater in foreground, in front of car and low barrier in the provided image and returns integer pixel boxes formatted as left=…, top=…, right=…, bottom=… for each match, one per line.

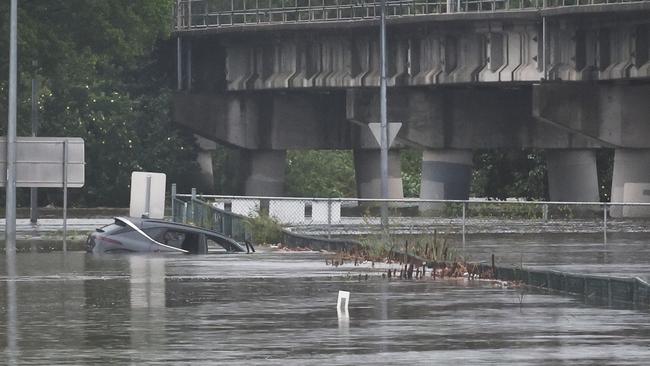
left=0, top=252, right=650, bottom=366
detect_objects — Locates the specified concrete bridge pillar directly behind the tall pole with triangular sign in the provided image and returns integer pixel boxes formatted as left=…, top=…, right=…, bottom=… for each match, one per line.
left=354, top=149, right=404, bottom=199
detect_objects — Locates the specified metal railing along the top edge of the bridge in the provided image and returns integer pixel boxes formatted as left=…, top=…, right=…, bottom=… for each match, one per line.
left=174, top=0, right=647, bottom=31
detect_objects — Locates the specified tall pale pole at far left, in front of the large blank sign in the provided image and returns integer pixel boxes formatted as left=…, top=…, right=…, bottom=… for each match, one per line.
left=5, top=0, right=18, bottom=254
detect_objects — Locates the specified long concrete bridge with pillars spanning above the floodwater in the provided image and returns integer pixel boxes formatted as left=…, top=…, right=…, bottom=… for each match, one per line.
left=175, top=0, right=650, bottom=209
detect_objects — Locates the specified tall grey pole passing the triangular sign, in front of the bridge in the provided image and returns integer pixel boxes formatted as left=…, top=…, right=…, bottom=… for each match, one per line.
left=379, top=0, right=388, bottom=242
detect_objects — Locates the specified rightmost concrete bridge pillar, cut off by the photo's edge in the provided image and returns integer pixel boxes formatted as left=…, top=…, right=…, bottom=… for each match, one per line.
left=610, top=149, right=650, bottom=217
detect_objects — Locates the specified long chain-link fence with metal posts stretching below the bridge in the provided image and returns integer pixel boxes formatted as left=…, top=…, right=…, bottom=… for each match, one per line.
left=173, top=190, right=650, bottom=247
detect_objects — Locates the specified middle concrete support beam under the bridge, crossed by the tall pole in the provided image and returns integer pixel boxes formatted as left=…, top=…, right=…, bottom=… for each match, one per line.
left=347, top=87, right=601, bottom=149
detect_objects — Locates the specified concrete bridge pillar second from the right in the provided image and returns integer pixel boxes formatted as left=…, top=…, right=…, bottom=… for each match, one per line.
left=546, top=149, right=600, bottom=202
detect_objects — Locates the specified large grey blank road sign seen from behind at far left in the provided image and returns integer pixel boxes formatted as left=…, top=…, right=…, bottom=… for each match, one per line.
left=0, top=137, right=85, bottom=188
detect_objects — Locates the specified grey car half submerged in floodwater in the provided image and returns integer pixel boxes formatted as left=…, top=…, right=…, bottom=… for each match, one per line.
left=86, top=217, right=248, bottom=254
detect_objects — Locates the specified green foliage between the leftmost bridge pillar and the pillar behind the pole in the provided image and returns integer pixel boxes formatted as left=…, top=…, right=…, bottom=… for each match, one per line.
left=285, top=150, right=356, bottom=197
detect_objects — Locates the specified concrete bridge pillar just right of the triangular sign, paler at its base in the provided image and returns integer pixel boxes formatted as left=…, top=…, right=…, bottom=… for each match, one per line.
left=420, top=150, right=473, bottom=202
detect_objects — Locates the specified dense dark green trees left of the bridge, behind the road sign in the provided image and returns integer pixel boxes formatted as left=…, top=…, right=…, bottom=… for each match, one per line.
left=0, top=0, right=196, bottom=206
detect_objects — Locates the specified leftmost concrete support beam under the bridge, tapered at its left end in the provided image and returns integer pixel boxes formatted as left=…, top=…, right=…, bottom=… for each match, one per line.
left=174, top=92, right=354, bottom=150
